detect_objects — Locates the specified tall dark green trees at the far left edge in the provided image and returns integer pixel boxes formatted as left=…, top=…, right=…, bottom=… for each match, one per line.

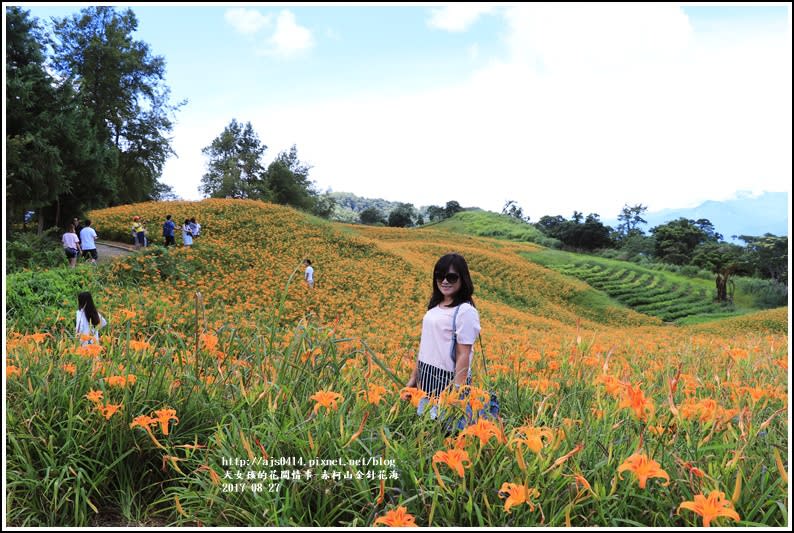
left=5, top=6, right=184, bottom=236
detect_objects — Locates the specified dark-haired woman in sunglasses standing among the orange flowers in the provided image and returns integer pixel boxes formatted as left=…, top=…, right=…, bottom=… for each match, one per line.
left=406, top=253, right=480, bottom=396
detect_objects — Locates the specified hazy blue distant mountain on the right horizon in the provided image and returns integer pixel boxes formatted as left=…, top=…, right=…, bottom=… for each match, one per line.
left=603, top=192, right=789, bottom=241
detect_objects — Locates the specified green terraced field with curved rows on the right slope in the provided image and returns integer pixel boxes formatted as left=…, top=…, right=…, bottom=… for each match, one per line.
left=532, top=260, right=733, bottom=322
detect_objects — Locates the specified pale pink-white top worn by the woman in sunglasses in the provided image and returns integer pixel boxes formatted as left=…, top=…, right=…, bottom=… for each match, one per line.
left=419, top=303, right=480, bottom=371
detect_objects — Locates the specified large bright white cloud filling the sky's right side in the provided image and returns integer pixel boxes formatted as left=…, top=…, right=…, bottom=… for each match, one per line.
left=159, top=6, right=792, bottom=220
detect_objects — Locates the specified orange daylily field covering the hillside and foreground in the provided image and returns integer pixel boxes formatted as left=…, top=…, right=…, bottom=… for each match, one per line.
left=5, top=200, right=790, bottom=527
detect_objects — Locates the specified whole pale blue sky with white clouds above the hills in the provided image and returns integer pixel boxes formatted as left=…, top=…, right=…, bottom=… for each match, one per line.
left=7, top=3, right=792, bottom=220
